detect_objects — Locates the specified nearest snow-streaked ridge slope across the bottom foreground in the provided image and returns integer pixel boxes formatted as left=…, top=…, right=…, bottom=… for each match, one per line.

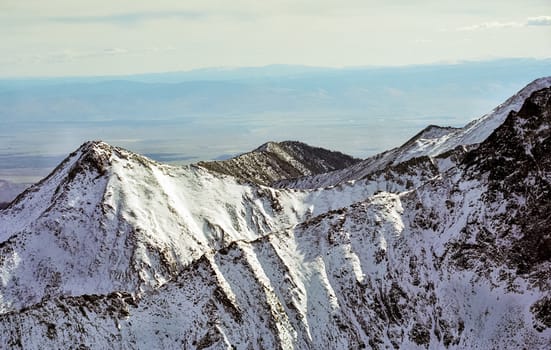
left=2, top=165, right=551, bottom=349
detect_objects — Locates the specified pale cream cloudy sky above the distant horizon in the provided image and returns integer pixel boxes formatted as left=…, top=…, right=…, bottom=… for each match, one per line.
left=0, top=0, right=551, bottom=77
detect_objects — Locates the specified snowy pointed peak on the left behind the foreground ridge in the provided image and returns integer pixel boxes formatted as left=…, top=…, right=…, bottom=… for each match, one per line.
left=0, top=142, right=384, bottom=311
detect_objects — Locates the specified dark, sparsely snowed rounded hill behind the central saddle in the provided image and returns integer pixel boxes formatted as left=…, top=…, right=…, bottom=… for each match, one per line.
left=198, top=141, right=360, bottom=186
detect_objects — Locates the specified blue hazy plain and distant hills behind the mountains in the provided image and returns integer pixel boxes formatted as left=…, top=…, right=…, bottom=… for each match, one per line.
left=0, top=59, right=551, bottom=182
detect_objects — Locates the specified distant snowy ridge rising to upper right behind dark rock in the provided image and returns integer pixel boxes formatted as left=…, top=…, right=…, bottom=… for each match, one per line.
left=274, top=77, right=551, bottom=189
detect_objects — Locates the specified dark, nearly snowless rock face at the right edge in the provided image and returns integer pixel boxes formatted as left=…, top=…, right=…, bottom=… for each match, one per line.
left=465, top=88, right=551, bottom=273
